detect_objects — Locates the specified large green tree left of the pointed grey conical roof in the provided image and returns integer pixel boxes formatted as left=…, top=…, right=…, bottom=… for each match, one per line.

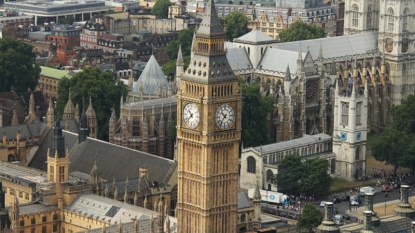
left=57, top=67, right=127, bottom=140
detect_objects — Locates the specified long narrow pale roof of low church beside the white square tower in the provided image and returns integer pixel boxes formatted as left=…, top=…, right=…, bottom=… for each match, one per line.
left=254, top=133, right=332, bottom=154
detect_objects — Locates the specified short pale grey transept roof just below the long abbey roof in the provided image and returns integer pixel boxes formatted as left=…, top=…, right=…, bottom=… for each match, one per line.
left=258, top=48, right=307, bottom=74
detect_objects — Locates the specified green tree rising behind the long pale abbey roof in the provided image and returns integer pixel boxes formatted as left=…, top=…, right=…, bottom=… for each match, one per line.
left=278, top=20, right=326, bottom=42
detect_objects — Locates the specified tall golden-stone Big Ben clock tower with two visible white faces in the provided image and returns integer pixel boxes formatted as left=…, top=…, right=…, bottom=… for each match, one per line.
left=177, top=0, right=242, bottom=233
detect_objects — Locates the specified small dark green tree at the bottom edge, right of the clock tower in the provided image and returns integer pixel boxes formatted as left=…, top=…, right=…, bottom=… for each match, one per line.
left=297, top=204, right=323, bottom=232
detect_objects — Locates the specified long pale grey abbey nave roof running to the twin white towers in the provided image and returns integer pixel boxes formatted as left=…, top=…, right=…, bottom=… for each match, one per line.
left=277, top=32, right=379, bottom=59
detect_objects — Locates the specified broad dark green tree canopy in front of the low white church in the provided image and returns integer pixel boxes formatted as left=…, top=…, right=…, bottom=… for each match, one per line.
left=275, top=154, right=333, bottom=196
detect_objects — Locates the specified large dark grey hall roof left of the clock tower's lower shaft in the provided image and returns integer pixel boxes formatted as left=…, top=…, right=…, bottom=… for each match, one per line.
left=29, top=131, right=175, bottom=182
